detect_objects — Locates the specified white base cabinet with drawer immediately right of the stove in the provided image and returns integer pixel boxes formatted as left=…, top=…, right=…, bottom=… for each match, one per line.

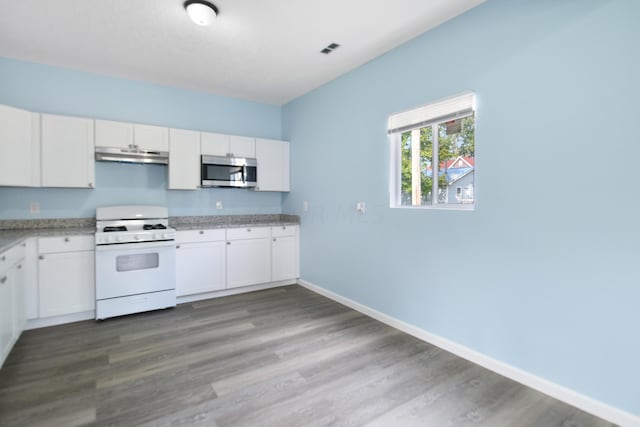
left=176, top=229, right=226, bottom=296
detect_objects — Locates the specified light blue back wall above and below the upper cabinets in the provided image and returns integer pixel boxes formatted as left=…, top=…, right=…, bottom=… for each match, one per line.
left=0, top=58, right=281, bottom=219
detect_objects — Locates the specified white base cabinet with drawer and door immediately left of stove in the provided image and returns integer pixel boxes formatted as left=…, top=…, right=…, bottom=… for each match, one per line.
left=38, top=236, right=95, bottom=318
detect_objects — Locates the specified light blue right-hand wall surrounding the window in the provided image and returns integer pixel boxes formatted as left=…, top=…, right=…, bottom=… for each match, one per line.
left=283, top=0, right=640, bottom=414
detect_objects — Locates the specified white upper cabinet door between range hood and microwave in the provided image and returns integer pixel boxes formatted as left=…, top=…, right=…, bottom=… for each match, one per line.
left=169, top=129, right=200, bottom=190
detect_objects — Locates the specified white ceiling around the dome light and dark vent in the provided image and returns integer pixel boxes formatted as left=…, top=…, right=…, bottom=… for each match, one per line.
left=0, top=0, right=485, bottom=105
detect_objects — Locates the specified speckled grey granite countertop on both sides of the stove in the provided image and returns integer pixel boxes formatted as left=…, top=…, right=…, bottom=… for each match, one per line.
left=0, top=214, right=300, bottom=252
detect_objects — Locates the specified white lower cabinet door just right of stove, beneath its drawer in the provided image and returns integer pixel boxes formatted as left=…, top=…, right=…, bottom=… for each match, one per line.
left=176, top=241, right=226, bottom=296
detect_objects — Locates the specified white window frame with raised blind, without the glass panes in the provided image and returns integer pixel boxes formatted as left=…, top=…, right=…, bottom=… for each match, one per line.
left=387, top=92, right=478, bottom=211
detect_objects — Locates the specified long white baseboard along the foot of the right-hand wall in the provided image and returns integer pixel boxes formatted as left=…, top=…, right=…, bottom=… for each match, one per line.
left=298, top=279, right=640, bottom=427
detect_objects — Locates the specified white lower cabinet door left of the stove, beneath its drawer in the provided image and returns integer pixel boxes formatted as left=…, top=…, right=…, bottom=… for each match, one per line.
left=38, top=251, right=96, bottom=317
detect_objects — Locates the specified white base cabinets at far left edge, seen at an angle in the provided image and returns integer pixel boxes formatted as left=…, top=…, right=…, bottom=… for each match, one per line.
left=0, top=244, right=25, bottom=366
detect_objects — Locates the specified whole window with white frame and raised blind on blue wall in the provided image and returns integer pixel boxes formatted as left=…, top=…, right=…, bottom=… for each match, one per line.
left=388, top=93, right=476, bottom=209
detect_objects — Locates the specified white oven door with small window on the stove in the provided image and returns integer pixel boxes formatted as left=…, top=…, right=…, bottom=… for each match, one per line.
left=96, top=241, right=176, bottom=300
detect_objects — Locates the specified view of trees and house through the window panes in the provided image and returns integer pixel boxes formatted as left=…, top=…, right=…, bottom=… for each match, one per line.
left=400, top=116, right=475, bottom=206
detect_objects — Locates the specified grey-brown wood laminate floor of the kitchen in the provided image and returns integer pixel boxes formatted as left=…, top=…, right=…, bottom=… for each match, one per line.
left=0, top=286, right=612, bottom=427
